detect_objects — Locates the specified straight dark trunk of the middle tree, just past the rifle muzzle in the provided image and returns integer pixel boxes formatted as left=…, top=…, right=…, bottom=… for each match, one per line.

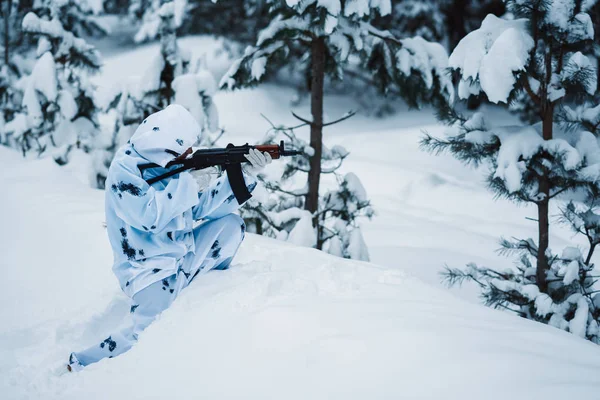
left=304, top=37, right=326, bottom=247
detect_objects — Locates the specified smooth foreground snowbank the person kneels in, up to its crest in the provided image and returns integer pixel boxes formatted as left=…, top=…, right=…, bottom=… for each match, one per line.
left=0, top=148, right=600, bottom=400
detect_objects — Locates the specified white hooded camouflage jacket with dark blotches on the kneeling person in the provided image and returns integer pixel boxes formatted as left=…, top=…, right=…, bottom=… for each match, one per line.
left=105, top=105, right=256, bottom=297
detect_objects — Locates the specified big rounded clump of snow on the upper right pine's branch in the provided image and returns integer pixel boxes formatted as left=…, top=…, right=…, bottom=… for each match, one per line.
left=449, top=14, right=534, bottom=103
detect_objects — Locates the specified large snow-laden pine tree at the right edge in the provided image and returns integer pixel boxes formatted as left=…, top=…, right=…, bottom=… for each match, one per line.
left=423, top=0, right=600, bottom=342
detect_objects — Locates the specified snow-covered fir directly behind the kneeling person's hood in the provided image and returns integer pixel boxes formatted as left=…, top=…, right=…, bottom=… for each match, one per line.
left=94, top=2, right=219, bottom=188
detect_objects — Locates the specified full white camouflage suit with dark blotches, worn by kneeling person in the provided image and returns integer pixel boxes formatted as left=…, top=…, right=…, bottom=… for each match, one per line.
left=69, top=105, right=258, bottom=370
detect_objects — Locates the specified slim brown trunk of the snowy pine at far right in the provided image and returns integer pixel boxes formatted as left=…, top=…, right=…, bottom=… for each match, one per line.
left=536, top=104, right=554, bottom=293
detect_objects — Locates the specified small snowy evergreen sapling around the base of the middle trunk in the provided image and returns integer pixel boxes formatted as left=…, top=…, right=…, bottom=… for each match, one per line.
left=241, top=118, right=373, bottom=261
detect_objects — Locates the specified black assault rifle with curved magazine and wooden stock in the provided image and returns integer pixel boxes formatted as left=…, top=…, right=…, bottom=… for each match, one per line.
left=138, top=140, right=302, bottom=204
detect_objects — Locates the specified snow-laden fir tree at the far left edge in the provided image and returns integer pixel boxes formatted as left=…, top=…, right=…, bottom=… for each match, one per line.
left=4, top=0, right=101, bottom=164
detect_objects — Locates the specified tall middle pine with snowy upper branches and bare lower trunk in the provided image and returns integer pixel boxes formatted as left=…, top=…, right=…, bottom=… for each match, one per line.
left=221, top=0, right=453, bottom=258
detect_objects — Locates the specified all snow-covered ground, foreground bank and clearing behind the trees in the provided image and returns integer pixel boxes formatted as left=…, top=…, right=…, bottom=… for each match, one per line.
left=0, top=37, right=600, bottom=400
